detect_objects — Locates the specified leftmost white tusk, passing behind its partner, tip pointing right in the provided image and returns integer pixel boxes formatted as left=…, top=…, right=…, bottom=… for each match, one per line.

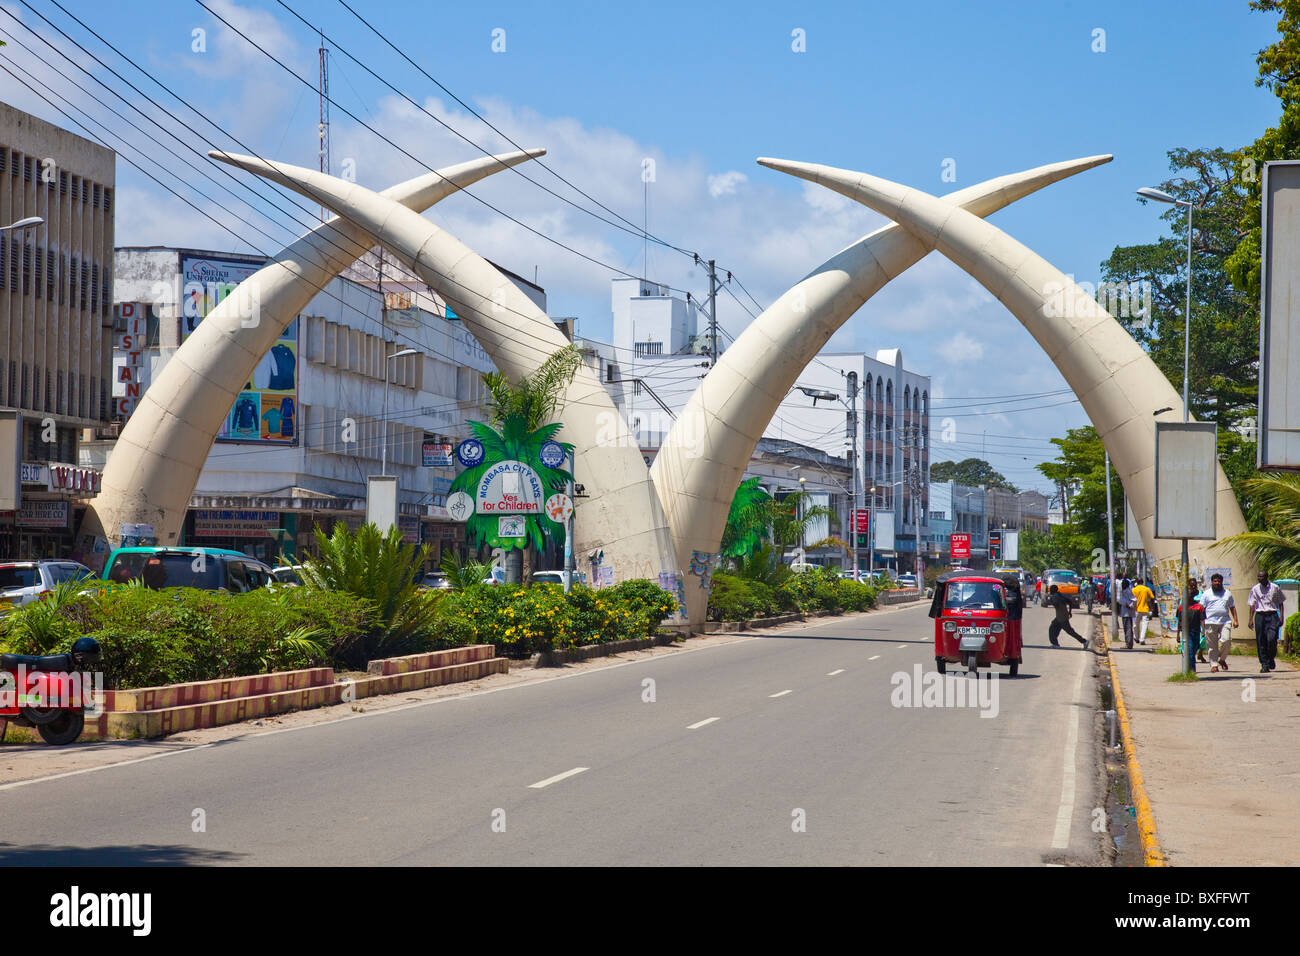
left=81, top=148, right=546, bottom=546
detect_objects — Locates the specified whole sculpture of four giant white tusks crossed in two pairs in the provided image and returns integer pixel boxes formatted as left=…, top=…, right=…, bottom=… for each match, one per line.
left=81, top=150, right=1253, bottom=627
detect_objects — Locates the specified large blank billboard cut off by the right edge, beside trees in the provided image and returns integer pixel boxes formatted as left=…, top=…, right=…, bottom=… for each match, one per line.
left=1256, top=160, right=1300, bottom=468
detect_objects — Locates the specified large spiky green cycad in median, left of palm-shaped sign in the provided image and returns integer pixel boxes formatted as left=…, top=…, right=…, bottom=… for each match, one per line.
left=298, top=522, right=437, bottom=653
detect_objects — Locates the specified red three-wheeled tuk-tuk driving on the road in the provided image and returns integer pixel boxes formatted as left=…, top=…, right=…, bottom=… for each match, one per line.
left=930, top=571, right=1024, bottom=678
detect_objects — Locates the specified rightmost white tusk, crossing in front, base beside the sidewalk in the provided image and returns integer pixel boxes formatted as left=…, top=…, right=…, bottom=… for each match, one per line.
left=759, top=159, right=1256, bottom=606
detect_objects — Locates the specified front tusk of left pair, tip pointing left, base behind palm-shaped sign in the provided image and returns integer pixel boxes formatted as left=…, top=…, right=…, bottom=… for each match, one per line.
left=209, top=152, right=677, bottom=595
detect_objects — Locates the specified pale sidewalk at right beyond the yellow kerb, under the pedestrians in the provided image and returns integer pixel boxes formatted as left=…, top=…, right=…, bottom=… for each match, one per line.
left=1106, top=622, right=1300, bottom=866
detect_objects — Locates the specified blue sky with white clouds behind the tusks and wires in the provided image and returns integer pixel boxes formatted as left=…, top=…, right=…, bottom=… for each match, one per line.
left=0, top=0, right=1277, bottom=488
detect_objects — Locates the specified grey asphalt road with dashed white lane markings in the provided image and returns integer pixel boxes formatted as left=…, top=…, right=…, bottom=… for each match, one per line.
left=0, top=605, right=1099, bottom=865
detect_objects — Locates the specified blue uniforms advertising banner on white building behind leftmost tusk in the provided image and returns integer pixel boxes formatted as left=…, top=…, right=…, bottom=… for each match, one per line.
left=181, top=256, right=298, bottom=445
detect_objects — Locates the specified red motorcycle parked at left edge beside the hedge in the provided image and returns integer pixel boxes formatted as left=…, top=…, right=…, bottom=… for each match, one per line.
left=0, top=637, right=100, bottom=747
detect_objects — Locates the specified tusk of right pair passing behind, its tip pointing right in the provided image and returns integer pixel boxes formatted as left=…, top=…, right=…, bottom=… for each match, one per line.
left=651, top=155, right=1110, bottom=623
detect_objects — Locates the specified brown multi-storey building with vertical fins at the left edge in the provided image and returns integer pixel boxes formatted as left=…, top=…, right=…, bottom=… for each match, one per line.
left=0, top=103, right=116, bottom=557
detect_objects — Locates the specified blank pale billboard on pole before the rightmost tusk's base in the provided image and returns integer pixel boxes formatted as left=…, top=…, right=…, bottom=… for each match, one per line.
left=1156, top=421, right=1218, bottom=541
